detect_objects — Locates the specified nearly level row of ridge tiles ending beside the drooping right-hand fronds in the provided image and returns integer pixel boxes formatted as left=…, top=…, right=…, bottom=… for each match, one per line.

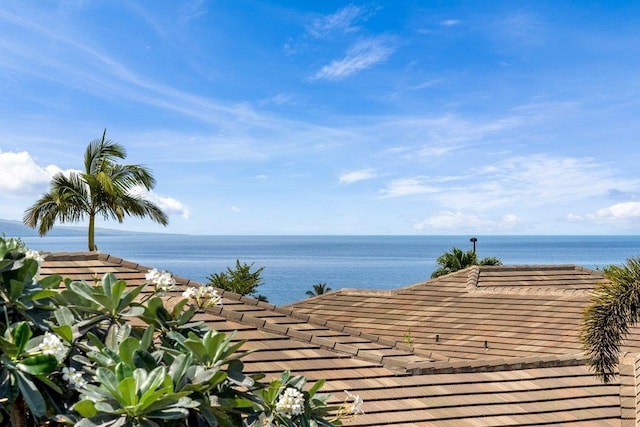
left=408, top=353, right=587, bottom=375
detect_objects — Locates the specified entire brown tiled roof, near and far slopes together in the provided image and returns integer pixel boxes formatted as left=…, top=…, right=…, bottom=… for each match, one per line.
left=42, top=253, right=640, bottom=426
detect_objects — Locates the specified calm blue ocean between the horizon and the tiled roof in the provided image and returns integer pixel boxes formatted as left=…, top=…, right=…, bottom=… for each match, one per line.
left=18, top=234, right=640, bottom=305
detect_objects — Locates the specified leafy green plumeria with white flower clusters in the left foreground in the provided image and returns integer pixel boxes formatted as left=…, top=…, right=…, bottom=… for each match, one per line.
left=0, top=238, right=362, bottom=427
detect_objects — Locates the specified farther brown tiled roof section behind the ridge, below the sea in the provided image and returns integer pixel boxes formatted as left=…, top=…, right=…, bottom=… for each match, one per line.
left=289, top=265, right=640, bottom=360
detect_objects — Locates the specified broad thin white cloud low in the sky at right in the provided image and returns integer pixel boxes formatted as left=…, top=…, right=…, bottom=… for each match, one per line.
left=381, top=155, right=640, bottom=220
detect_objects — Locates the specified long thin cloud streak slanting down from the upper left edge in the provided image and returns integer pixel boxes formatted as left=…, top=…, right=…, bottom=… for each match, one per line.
left=0, top=7, right=264, bottom=126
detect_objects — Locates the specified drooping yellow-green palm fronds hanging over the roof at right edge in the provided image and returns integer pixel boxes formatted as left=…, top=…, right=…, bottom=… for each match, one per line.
left=579, top=257, right=640, bottom=383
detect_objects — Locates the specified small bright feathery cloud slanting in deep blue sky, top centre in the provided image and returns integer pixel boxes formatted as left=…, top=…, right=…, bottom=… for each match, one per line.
left=313, top=37, right=395, bottom=80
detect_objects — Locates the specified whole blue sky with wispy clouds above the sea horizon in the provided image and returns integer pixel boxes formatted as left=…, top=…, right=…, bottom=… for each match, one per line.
left=0, top=0, right=640, bottom=235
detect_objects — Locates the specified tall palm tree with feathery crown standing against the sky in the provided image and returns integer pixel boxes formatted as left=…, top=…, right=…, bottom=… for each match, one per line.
left=22, top=129, right=169, bottom=251
